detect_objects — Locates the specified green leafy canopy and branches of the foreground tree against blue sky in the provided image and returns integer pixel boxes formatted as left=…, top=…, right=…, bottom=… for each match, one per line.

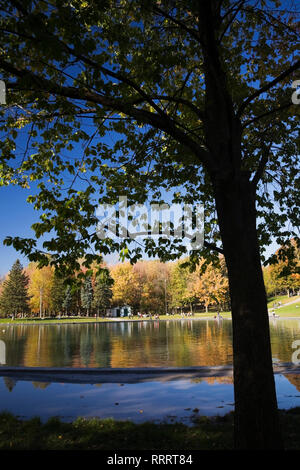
left=0, top=0, right=300, bottom=271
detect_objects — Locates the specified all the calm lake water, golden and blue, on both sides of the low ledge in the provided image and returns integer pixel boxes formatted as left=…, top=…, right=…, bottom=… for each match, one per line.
left=0, top=319, right=300, bottom=424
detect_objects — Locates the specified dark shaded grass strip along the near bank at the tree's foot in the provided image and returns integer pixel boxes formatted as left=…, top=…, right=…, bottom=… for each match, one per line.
left=0, top=408, right=300, bottom=450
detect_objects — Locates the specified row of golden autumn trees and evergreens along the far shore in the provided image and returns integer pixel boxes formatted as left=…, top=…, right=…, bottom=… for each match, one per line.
left=0, top=246, right=300, bottom=320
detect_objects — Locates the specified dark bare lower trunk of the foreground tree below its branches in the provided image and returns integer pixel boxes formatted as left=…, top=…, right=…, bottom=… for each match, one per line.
left=213, top=173, right=282, bottom=449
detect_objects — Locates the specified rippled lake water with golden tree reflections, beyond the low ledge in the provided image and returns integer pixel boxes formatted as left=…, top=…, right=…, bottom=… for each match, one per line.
left=0, top=319, right=300, bottom=368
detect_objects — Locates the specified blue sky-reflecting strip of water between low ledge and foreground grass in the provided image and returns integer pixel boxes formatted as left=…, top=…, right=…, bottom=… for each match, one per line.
left=0, top=375, right=300, bottom=423
